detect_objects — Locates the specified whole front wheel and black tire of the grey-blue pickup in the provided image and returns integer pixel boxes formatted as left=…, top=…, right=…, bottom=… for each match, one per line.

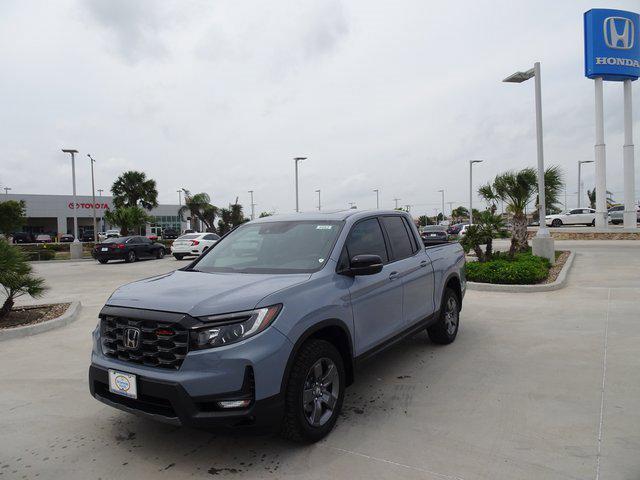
left=280, top=339, right=346, bottom=443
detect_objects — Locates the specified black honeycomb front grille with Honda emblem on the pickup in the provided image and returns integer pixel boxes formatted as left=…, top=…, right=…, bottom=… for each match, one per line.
left=100, top=316, right=189, bottom=369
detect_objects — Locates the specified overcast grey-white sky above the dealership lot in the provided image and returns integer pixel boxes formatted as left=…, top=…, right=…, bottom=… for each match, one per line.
left=0, top=0, right=640, bottom=215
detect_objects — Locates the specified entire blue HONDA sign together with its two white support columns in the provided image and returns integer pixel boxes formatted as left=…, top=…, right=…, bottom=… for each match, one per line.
left=584, top=8, right=640, bottom=229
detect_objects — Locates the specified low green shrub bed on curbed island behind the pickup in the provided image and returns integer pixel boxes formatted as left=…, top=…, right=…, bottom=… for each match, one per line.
left=466, top=253, right=549, bottom=285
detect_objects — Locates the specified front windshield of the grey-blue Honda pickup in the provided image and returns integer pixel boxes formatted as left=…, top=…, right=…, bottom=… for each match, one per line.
left=193, top=220, right=343, bottom=273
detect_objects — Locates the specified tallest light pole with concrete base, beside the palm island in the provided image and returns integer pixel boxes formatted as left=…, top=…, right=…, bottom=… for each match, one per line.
left=503, top=62, right=555, bottom=264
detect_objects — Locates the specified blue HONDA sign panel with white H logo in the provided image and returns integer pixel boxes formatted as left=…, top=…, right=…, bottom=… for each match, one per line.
left=584, top=8, right=640, bottom=81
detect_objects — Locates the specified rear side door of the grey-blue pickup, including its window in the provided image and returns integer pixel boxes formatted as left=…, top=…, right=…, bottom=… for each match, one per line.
left=382, top=215, right=434, bottom=326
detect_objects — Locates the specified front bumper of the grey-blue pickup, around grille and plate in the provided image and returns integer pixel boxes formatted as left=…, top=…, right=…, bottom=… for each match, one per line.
left=89, top=307, right=293, bottom=428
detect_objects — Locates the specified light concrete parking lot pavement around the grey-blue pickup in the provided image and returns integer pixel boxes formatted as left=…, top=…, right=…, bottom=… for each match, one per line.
left=0, top=241, right=640, bottom=480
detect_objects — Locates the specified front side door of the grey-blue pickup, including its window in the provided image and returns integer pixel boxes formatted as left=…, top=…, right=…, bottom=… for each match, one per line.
left=340, top=217, right=404, bottom=355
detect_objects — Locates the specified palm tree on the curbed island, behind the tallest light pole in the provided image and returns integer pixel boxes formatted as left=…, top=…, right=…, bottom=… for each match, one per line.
left=478, top=166, right=563, bottom=256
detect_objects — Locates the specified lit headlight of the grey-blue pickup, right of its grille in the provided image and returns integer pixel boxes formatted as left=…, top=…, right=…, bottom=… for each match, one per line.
left=191, top=304, right=282, bottom=350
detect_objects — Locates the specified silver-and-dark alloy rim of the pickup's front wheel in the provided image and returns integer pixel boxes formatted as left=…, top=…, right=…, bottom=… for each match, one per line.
left=302, top=357, right=340, bottom=427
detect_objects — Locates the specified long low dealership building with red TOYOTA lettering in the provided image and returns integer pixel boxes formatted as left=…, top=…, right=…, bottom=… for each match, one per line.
left=5, top=194, right=188, bottom=236
